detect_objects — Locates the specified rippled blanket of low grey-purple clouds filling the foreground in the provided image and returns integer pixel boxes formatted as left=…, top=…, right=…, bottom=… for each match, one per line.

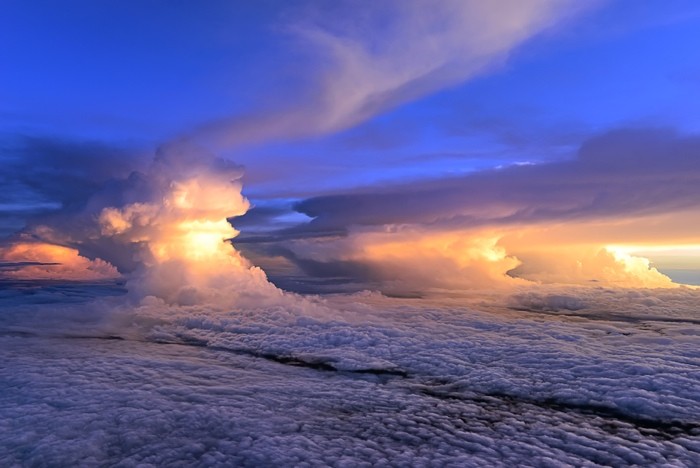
left=0, top=286, right=700, bottom=466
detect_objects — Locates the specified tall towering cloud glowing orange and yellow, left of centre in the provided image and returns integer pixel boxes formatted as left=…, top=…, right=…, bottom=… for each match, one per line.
left=93, top=148, right=278, bottom=305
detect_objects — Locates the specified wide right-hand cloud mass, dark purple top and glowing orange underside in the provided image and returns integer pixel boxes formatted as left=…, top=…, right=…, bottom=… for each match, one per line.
left=245, top=128, right=700, bottom=289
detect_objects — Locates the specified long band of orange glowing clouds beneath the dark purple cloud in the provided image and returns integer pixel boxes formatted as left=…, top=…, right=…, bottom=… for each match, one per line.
left=294, top=221, right=678, bottom=291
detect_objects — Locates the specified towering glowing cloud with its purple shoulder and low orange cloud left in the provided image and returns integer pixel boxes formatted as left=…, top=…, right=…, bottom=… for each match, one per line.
left=4, top=143, right=294, bottom=304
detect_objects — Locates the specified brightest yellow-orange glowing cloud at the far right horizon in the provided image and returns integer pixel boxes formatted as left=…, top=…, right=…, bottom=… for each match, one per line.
left=500, top=217, right=700, bottom=287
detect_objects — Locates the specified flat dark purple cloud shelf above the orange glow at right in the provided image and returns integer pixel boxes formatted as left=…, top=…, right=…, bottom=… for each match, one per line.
left=296, top=129, right=700, bottom=233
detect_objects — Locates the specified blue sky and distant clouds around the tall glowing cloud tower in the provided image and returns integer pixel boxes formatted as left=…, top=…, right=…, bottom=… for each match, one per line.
left=0, top=0, right=700, bottom=294
